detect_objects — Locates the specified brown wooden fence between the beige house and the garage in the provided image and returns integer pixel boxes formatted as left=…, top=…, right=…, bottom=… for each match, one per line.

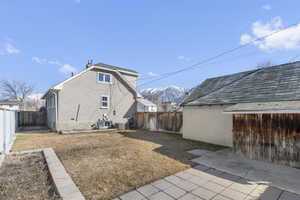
left=136, top=112, right=182, bottom=133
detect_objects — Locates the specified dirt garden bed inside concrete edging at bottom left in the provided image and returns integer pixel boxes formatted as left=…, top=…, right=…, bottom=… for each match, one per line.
left=0, top=153, right=61, bottom=200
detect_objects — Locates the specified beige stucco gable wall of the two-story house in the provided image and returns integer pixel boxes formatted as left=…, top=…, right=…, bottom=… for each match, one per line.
left=58, top=70, right=136, bottom=130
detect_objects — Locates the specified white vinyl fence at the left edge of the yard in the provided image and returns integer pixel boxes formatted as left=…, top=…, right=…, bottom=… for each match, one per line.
left=0, top=108, right=16, bottom=154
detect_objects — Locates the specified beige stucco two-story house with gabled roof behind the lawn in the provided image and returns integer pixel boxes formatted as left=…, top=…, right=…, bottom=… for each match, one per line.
left=42, top=63, right=146, bottom=131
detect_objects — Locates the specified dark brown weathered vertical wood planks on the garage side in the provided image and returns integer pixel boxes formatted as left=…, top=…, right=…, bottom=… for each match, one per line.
left=233, top=114, right=300, bottom=168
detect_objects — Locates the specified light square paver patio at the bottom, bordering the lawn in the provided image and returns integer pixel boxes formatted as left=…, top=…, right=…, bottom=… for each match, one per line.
left=115, top=165, right=300, bottom=200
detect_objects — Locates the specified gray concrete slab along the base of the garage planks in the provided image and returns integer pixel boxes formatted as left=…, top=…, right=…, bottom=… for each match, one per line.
left=192, top=149, right=300, bottom=194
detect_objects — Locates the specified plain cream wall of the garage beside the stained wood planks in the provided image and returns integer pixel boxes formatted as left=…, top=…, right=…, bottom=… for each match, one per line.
left=183, top=105, right=233, bottom=147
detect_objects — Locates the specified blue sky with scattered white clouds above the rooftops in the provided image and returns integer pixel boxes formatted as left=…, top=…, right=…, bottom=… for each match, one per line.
left=0, top=0, right=300, bottom=92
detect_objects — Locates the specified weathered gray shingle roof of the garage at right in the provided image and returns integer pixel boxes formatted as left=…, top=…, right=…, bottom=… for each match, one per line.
left=183, top=62, right=300, bottom=105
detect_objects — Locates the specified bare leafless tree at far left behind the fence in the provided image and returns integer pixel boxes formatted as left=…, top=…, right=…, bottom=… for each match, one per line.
left=0, top=80, right=35, bottom=103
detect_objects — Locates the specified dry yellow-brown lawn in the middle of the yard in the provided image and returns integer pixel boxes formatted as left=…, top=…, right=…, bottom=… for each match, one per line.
left=13, top=131, right=222, bottom=200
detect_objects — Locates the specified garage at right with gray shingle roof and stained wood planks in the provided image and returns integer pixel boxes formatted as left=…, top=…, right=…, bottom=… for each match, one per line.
left=182, top=62, right=300, bottom=167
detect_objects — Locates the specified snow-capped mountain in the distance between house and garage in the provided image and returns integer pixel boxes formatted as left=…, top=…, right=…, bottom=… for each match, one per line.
left=140, top=85, right=188, bottom=104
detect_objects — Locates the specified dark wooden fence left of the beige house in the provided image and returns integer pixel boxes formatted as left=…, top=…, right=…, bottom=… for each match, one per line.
left=18, top=111, right=47, bottom=127
